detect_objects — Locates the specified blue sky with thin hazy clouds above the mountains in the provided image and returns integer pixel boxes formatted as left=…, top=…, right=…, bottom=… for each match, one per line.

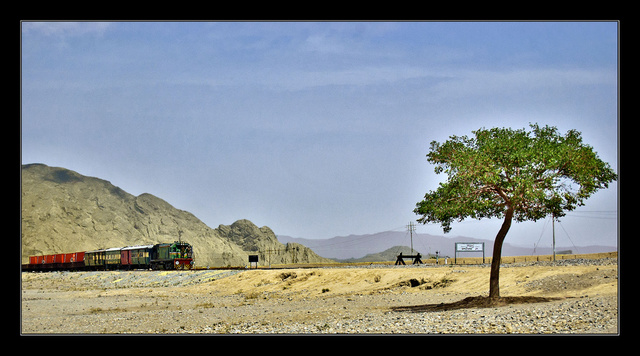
left=21, top=21, right=619, bottom=250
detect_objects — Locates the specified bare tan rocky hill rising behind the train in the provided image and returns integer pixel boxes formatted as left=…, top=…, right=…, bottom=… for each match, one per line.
left=21, top=164, right=329, bottom=266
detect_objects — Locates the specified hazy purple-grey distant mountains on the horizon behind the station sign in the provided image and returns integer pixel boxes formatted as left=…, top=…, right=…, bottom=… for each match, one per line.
left=277, top=231, right=617, bottom=260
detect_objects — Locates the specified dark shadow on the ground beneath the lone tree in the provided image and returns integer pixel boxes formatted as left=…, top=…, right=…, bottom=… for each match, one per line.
left=391, top=296, right=566, bottom=313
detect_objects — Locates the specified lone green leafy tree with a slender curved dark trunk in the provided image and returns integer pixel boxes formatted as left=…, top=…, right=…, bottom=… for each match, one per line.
left=414, top=124, right=617, bottom=298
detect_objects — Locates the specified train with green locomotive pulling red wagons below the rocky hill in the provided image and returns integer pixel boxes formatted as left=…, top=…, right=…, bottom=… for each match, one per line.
left=22, top=241, right=194, bottom=272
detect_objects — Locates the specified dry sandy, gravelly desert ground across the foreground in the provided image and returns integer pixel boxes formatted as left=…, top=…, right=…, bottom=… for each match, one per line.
left=21, top=258, right=619, bottom=335
